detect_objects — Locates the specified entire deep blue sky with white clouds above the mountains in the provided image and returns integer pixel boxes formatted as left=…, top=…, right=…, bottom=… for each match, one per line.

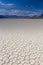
left=0, top=0, right=43, bottom=16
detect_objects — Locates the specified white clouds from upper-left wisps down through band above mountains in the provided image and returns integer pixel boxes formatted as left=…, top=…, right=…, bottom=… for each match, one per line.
left=0, top=2, right=43, bottom=16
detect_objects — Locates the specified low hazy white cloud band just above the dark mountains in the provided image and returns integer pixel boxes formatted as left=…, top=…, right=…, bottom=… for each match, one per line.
left=0, top=9, right=40, bottom=16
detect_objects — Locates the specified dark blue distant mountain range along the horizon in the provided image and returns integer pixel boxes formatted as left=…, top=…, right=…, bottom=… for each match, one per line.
left=0, top=13, right=43, bottom=19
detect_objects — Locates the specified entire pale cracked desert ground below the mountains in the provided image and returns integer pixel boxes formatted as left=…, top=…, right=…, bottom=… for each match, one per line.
left=0, top=19, right=43, bottom=65
